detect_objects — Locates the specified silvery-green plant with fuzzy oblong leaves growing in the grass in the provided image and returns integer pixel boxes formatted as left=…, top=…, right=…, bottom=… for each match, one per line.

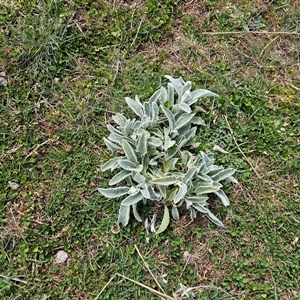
left=99, top=75, right=237, bottom=234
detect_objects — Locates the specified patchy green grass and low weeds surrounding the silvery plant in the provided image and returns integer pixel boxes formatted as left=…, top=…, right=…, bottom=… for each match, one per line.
left=0, top=0, right=300, bottom=300
